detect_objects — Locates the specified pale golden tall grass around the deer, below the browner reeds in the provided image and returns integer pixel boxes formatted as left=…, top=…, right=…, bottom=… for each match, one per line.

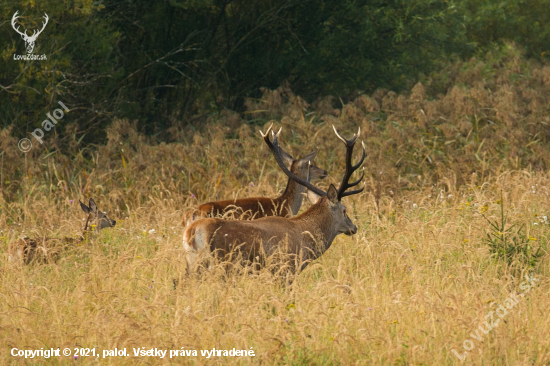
left=0, top=134, right=550, bottom=365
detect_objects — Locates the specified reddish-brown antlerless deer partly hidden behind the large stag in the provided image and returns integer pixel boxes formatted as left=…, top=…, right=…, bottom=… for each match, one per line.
left=182, top=133, right=327, bottom=226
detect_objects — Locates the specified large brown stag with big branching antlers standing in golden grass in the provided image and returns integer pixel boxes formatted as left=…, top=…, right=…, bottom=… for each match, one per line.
left=183, top=126, right=365, bottom=272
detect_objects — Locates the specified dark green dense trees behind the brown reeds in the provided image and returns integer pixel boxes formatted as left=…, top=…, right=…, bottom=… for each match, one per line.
left=0, top=0, right=550, bottom=140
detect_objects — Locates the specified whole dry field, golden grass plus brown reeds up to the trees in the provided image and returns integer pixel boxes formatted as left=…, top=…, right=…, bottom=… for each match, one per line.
left=0, top=46, right=550, bottom=365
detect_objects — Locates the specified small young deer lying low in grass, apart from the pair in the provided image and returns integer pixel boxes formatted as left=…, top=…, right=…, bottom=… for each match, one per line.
left=8, top=198, right=116, bottom=264
